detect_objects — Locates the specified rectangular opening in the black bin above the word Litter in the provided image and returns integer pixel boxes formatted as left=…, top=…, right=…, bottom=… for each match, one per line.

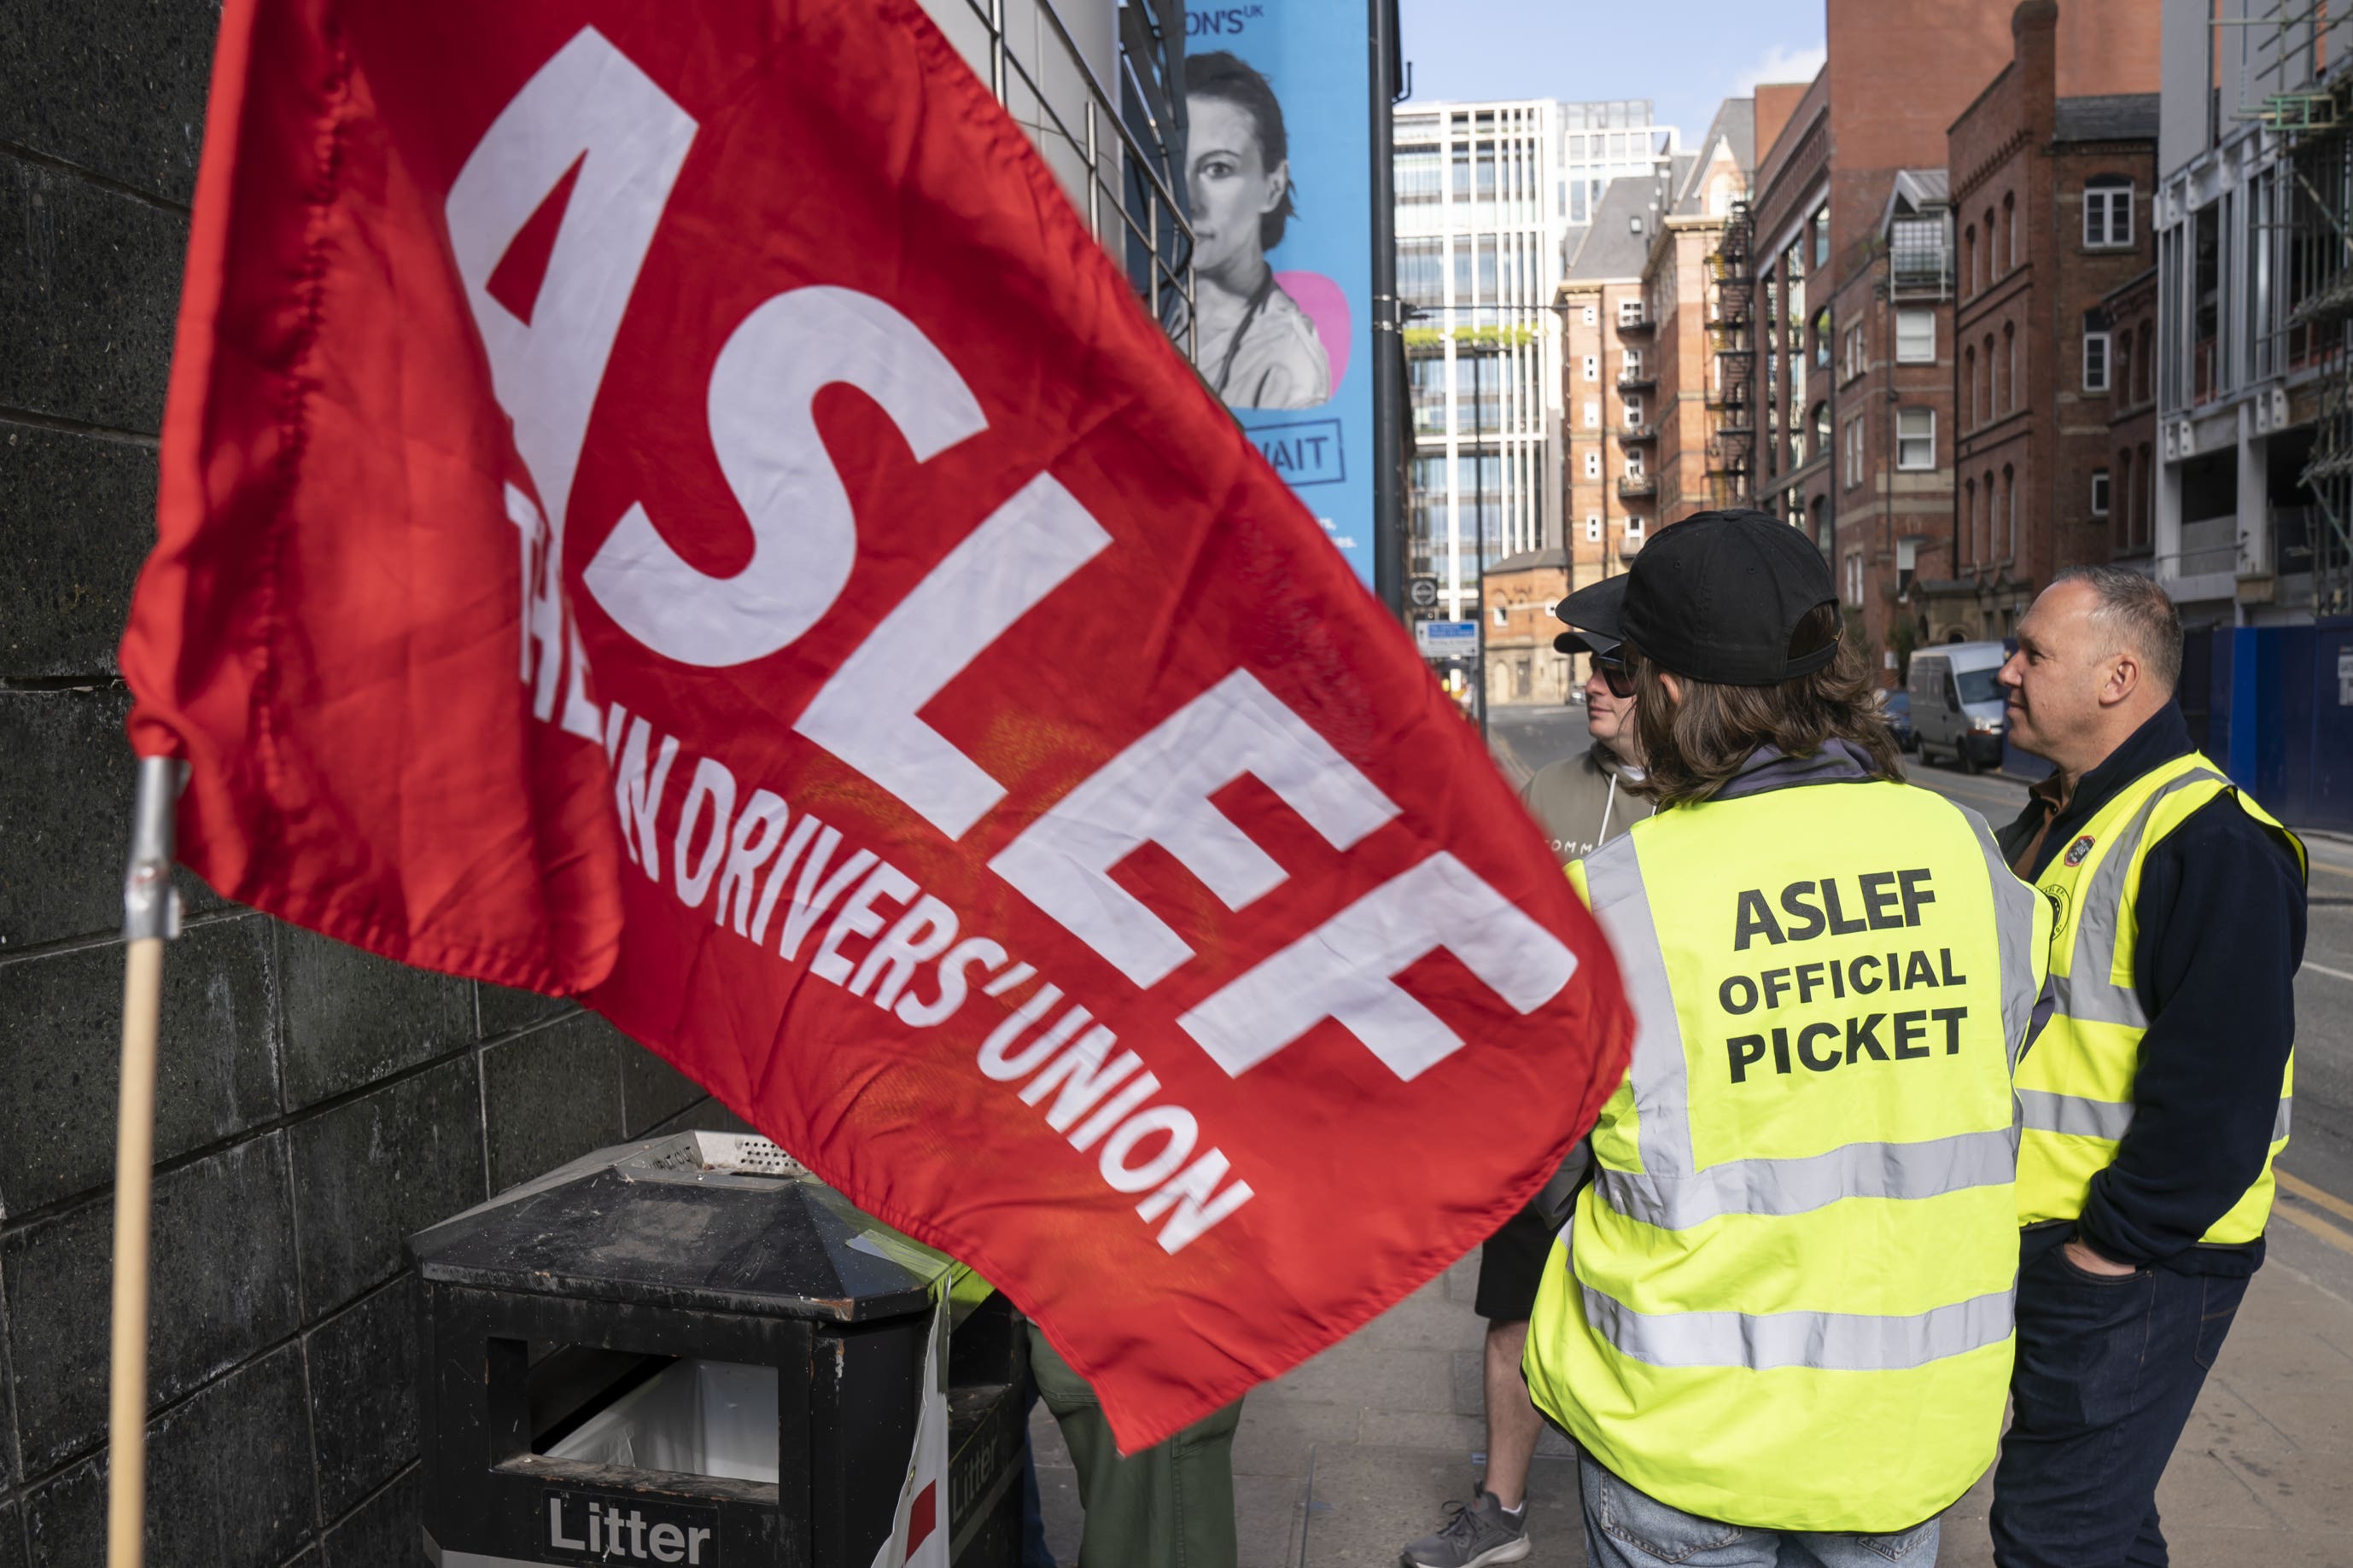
left=529, top=1344, right=779, bottom=1486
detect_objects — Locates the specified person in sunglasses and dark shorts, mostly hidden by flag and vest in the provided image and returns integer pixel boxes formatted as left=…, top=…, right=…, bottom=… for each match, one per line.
left=1404, top=576, right=1652, bottom=1568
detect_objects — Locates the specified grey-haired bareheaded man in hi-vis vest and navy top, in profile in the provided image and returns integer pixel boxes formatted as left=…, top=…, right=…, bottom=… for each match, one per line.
left=1993, top=567, right=2306, bottom=1568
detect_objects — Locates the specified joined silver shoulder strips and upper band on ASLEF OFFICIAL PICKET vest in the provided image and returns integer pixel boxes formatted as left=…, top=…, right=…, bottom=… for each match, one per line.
left=1586, top=807, right=2040, bottom=1229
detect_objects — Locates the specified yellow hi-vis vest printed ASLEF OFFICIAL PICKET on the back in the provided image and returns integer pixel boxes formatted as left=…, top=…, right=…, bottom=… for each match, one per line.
left=1522, top=783, right=2049, bottom=1533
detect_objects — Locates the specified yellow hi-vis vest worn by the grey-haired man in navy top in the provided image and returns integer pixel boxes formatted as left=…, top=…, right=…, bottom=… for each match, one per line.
left=2019, top=752, right=2309, bottom=1244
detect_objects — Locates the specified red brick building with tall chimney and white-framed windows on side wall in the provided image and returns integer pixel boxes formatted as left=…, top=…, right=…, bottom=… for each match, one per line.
left=1908, top=0, right=2160, bottom=642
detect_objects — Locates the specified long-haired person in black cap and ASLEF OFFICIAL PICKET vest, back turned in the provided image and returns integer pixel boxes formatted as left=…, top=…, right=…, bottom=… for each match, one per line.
left=1525, top=512, right=2052, bottom=1568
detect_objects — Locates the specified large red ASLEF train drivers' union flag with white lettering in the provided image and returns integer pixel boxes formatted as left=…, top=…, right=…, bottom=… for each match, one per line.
left=122, top=0, right=1628, bottom=1446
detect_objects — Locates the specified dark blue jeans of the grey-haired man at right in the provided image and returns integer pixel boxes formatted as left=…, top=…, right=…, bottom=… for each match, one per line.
left=1993, top=1246, right=2247, bottom=1568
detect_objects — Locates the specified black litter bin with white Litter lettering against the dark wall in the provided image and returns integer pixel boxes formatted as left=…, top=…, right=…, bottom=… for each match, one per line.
left=410, top=1133, right=1028, bottom=1568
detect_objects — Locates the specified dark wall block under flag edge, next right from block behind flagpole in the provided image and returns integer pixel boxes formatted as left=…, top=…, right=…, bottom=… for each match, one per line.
left=277, top=926, right=473, bottom=1110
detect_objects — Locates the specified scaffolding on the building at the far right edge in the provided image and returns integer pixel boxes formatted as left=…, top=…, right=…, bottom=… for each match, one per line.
left=2214, top=0, right=2353, bottom=618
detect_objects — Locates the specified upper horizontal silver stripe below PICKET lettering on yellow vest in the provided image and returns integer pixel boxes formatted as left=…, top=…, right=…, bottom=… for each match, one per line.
left=1593, top=1128, right=2017, bottom=1229
